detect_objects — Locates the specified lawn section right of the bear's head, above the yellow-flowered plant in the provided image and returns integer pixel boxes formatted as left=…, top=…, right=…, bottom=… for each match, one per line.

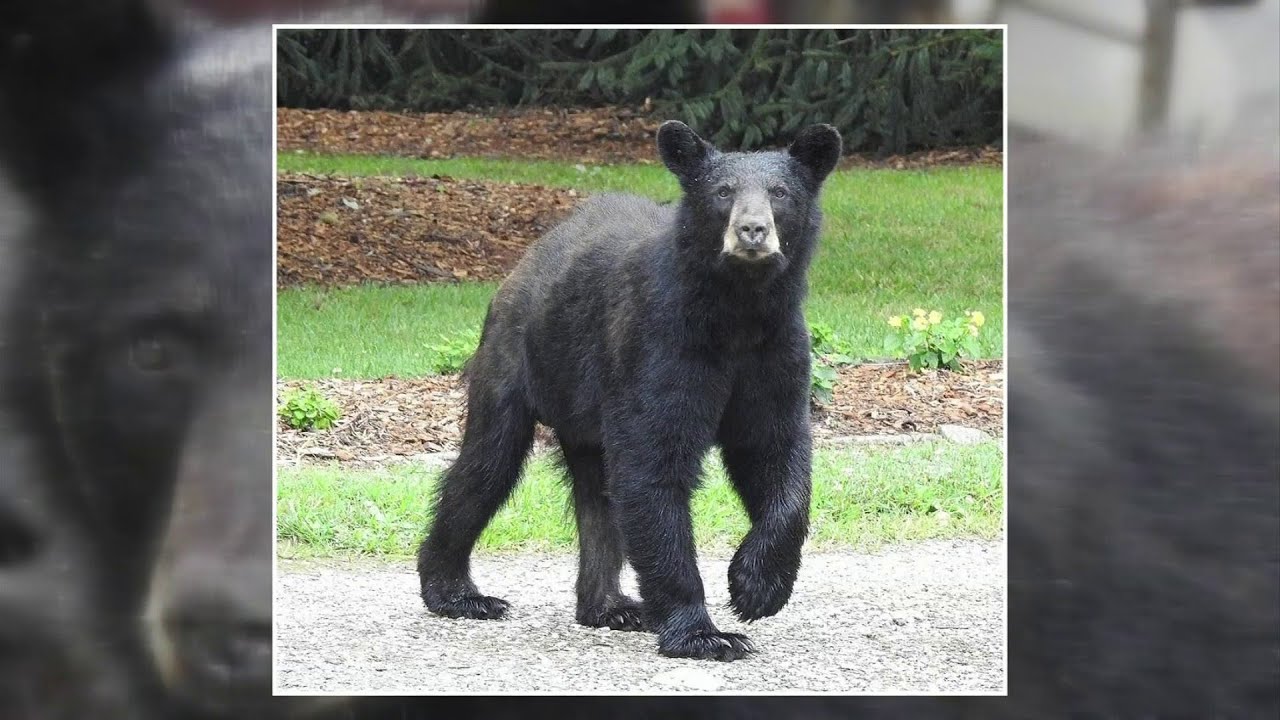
left=808, top=168, right=1004, bottom=357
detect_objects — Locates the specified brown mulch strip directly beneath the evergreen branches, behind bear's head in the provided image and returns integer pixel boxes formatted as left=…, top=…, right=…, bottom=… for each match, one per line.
left=276, top=108, right=1004, bottom=169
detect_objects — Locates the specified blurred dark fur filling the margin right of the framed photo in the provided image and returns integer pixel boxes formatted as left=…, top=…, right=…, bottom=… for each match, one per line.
left=1005, top=141, right=1280, bottom=717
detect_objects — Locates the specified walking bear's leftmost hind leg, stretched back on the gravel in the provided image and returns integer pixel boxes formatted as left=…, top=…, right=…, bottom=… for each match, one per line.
left=417, top=378, right=534, bottom=620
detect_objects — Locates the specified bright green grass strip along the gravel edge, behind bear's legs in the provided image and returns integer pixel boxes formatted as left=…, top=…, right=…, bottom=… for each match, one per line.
left=276, top=442, right=1004, bottom=557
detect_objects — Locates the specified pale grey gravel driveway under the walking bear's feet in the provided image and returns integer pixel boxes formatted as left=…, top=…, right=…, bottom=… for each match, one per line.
left=275, top=541, right=1005, bottom=694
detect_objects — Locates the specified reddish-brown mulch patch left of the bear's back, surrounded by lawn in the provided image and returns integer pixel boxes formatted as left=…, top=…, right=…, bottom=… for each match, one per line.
left=276, top=174, right=582, bottom=287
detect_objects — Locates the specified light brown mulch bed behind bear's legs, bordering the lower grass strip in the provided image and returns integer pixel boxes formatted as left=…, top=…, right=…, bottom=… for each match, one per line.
left=276, top=360, right=1005, bottom=464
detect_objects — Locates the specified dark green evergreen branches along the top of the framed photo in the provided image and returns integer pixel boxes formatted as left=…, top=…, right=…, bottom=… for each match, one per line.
left=278, top=28, right=1002, bottom=154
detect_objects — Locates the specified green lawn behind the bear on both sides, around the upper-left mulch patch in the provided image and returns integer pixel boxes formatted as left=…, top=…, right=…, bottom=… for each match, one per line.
left=279, top=155, right=1004, bottom=378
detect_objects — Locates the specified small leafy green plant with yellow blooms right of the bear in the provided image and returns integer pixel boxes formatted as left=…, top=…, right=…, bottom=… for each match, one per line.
left=884, top=307, right=987, bottom=373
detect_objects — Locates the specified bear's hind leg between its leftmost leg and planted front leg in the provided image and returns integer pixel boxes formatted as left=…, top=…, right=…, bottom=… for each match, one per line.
left=561, top=439, right=644, bottom=630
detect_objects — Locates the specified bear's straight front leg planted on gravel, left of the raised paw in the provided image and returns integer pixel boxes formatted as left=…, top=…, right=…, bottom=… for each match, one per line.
left=605, top=392, right=754, bottom=661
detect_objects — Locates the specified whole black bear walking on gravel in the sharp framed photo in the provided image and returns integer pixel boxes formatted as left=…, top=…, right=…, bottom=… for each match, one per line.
left=419, top=120, right=841, bottom=660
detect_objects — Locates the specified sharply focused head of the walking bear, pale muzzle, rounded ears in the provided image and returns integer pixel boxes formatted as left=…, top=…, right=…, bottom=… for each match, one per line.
left=658, top=120, right=841, bottom=272
